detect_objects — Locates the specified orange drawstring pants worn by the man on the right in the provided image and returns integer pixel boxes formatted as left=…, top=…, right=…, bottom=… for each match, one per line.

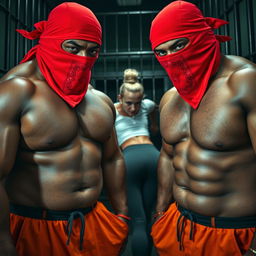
left=151, top=203, right=256, bottom=256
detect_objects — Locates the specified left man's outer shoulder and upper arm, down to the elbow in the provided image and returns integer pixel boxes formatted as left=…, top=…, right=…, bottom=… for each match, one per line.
left=0, top=78, right=34, bottom=178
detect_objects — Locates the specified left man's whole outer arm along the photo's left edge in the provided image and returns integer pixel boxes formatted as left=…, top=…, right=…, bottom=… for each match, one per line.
left=0, top=79, right=33, bottom=256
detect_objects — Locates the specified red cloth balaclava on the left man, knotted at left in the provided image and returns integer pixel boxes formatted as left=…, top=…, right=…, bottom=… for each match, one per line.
left=17, top=2, right=102, bottom=107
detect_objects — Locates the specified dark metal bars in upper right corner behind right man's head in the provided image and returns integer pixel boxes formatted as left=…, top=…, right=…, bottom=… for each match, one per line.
left=201, top=0, right=256, bottom=62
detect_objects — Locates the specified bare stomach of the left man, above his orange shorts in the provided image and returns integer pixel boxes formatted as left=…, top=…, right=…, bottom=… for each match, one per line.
left=6, top=142, right=102, bottom=210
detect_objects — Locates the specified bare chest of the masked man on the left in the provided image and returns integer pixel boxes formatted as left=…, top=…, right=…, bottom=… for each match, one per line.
left=21, top=83, right=113, bottom=151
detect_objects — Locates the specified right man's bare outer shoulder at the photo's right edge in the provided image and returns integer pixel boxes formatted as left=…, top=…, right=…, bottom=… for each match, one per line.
left=228, top=56, right=256, bottom=109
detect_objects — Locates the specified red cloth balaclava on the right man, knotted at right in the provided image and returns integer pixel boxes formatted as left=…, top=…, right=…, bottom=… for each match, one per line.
left=150, top=0, right=231, bottom=109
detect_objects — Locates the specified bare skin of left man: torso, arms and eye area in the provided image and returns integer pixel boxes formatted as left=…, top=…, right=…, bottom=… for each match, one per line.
left=0, top=40, right=127, bottom=256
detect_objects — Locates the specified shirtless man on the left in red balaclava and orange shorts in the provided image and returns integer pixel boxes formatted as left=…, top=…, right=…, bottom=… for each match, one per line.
left=0, top=3, right=128, bottom=256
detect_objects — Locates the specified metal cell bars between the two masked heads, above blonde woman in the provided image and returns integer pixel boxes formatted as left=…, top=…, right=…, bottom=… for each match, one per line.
left=92, top=11, right=167, bottom=102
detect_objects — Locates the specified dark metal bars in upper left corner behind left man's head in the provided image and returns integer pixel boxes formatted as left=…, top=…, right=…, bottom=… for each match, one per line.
left=0, top=0, right=48, bottom=76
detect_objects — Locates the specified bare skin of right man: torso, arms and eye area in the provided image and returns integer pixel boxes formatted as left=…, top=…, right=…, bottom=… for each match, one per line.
left=155, top=38, right=256, bottom=255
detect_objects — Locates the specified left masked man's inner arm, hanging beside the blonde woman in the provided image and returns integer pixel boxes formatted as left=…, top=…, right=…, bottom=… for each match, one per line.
left=103, top=129, right=128, bottom=215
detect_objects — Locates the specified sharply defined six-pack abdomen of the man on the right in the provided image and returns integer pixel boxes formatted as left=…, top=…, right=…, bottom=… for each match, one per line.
left=173, top=140, right=256, bottom=217
